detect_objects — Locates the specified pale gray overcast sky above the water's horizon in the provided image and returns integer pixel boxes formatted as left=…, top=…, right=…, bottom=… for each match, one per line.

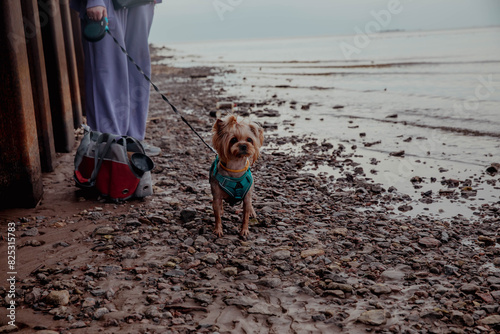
left=150, top=0, right=500, bottom=45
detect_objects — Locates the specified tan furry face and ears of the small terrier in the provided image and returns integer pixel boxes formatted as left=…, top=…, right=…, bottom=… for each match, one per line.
left=212, top=115, right=264, bottom=164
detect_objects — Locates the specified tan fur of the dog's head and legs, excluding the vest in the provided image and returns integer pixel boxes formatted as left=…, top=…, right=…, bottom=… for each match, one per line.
left=210, top=115, right=264, bottom=237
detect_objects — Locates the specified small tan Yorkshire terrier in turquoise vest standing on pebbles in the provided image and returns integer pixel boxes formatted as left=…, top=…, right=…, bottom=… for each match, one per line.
left=210, top=115, right=264, bottom=237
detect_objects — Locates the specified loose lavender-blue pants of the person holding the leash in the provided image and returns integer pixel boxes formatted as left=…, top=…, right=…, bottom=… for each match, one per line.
left=83, top=0, right=154, bottom=140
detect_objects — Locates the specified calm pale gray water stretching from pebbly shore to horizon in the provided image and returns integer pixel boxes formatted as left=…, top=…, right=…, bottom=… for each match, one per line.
left=157, top=27, right=500, bottom=218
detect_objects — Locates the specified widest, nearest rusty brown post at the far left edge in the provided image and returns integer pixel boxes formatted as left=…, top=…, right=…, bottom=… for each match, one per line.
left=0, top=1, right=43, bottom=207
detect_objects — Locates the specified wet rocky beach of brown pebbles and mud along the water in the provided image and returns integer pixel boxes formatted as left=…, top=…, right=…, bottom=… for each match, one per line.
left=0, top=44, right=500, bottom=334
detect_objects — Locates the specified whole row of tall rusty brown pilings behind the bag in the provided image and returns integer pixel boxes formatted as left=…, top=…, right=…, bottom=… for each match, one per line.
left=0, top=0, right=84, bottom=208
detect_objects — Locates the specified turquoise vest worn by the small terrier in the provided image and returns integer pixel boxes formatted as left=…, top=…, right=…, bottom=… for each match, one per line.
left=210, top=156, right=253, bottom=205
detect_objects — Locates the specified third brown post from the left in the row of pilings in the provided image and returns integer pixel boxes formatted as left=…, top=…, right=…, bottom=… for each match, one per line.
left=38, top=0, right=75, bottom=152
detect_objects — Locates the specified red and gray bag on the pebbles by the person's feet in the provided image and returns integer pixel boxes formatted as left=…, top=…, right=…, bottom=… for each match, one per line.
left=74, top=125, right=154, bottom=201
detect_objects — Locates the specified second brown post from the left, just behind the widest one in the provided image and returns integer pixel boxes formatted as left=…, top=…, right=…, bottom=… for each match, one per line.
left=21, top=0, right=56, bottom=172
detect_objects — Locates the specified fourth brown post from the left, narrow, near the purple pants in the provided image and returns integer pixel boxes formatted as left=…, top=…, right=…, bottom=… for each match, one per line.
left=59, top=0, right=82, bottom=129
